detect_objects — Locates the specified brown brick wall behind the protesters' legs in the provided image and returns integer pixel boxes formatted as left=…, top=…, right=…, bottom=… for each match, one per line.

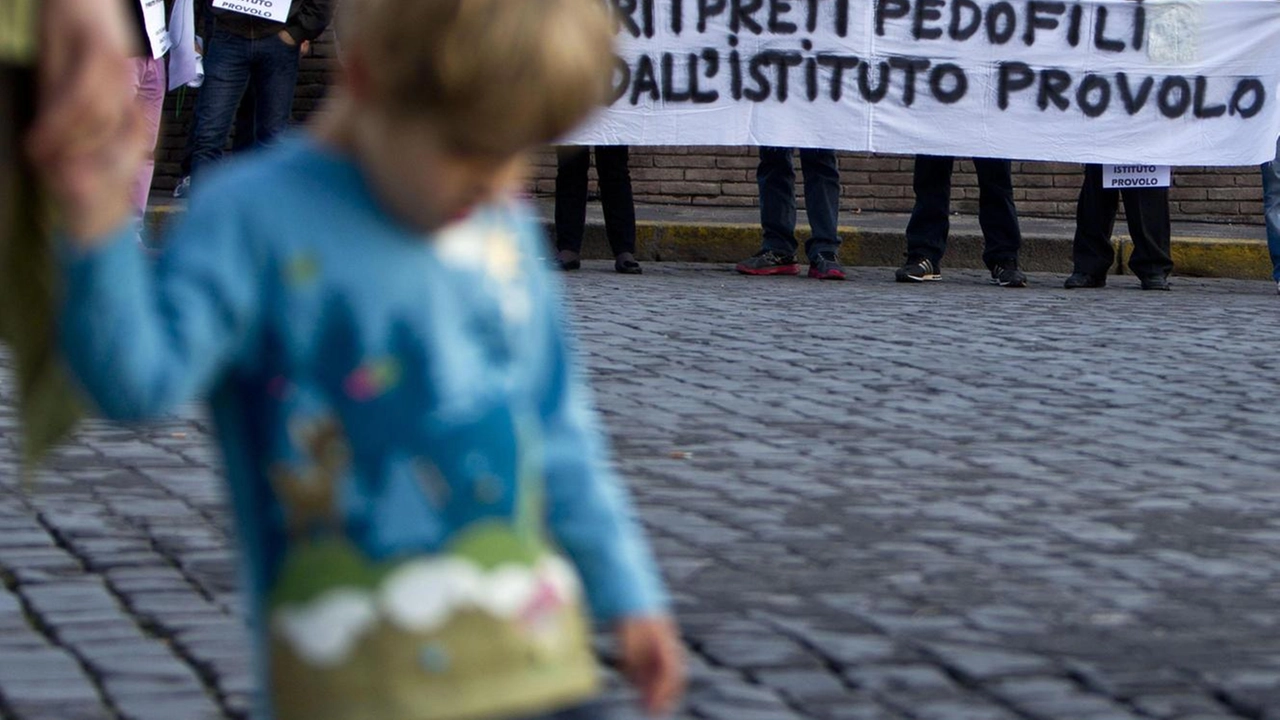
left=155, top=33, right=1262, bottom=223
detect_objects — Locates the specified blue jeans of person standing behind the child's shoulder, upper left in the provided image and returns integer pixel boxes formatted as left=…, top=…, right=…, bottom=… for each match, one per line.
left=191, top=29, right=301, bottom=176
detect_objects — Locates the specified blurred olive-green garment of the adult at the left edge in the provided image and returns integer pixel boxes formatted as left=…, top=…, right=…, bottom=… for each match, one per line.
left=0, top=65, right=79, bottom=471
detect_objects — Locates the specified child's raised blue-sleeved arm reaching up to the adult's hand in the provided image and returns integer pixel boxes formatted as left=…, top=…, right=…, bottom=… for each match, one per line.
left=59, top=175, right=262, bottom=420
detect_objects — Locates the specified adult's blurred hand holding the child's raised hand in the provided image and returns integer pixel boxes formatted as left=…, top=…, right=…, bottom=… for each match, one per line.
left=27, top=0, right=133, bottom=163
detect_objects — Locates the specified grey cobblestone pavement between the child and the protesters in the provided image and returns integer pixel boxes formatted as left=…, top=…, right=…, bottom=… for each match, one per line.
left=0, top=263, right=1280, bottom=720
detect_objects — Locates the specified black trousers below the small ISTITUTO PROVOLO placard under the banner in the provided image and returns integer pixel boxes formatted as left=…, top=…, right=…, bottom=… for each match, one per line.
left=1071, top=165, right=1174, bottom=278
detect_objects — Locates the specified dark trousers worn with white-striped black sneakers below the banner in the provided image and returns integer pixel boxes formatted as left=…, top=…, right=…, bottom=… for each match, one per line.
left=906, top=155, right=1023, bottom=268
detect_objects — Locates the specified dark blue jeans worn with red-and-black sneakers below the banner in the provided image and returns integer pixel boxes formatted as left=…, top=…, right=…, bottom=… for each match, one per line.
left=755, top=147, right=840, bottom=260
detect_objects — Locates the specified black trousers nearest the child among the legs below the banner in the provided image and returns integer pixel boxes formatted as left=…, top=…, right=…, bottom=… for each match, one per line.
left=556, top=145, right=636, bottom=255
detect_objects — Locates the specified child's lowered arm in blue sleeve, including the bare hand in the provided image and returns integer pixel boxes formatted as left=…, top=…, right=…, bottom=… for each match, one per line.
left=541, top=281, right=685, bottom=715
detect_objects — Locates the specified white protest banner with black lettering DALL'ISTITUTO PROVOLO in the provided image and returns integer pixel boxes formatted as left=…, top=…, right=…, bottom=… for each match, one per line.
left=568, top=0, right=1280, bottom=165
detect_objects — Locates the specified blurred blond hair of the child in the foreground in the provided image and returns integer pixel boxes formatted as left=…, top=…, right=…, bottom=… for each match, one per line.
left=338, top=0, right=613, bottom=156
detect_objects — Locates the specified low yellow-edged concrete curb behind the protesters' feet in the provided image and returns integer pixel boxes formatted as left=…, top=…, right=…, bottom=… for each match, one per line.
left=147, top=202, right=1271, bottom=279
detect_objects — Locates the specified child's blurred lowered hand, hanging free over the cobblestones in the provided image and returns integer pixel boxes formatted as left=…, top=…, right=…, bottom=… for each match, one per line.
left=617, top=616, right=685, bottom=715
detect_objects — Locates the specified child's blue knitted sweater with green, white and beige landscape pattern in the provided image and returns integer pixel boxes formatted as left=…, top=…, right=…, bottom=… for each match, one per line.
left=61, top=135, right=664, bottom=720
